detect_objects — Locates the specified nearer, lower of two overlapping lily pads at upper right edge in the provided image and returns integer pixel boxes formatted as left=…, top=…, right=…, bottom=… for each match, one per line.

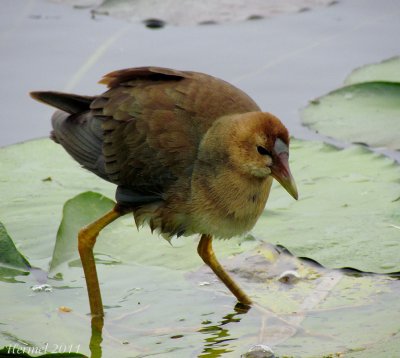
left=301, top=82, right=400, bottom=150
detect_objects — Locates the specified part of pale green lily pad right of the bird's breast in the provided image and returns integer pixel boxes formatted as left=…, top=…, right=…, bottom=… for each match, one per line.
left=253, top=141, right=400, bottom=273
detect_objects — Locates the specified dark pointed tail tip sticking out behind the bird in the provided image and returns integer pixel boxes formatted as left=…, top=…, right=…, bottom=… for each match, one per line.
left=30, top=91, right=95, bottom=114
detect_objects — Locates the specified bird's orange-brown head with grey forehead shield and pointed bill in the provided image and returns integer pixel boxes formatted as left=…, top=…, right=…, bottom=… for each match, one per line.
left=203, top=112, right=298, bottom=200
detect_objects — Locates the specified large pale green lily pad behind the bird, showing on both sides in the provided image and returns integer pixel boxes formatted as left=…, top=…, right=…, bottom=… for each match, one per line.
left=0, top=140, right=400, bottom=272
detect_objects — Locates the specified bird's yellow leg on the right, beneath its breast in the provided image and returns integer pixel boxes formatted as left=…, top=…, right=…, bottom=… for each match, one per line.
left=197, top=235, right=252, bottom=305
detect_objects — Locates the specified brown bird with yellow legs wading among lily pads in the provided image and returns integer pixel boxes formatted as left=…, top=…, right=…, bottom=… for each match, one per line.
left=30, top=66, right=298, bottom=317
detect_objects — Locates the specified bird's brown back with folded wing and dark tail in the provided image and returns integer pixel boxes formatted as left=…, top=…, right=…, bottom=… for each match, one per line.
left=32, top=67, right=259, bottom=203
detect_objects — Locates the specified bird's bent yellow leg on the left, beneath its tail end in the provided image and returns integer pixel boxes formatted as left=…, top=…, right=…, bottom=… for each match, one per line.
left=78, top=205, right=128, bottom=318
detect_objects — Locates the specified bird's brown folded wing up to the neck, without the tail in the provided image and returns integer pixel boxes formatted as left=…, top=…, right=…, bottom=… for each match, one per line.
left=91, top=67, right=259, bottom=194
